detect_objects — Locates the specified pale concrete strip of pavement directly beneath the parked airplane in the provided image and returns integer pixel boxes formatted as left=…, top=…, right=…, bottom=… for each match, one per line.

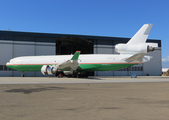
left=0, top=76, right=169, bottom=84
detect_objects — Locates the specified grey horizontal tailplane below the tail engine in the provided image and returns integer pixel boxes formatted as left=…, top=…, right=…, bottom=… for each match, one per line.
left=125, top=53, right=145, bottom=62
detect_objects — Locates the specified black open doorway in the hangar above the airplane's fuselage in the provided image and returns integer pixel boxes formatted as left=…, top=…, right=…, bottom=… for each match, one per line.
left=56, top=37, right=93, bottom=55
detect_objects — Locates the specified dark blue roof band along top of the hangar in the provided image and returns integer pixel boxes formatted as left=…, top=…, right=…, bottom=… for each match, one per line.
left=0, top=30, right=161, bottom=47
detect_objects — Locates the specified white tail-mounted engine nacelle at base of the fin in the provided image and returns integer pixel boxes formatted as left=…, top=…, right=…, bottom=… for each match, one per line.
left=115, top=44, right=154, bottom=53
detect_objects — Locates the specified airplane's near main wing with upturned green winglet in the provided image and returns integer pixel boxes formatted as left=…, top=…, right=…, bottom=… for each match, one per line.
left=58, top=51, right=80, bottom=71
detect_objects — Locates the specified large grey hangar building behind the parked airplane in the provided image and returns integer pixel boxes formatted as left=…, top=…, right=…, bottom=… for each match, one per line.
left=0, top=31, right=162, bottom=77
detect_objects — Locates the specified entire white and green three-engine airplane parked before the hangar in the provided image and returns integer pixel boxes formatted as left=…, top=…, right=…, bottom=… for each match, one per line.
left=6, top=24, right=158, bottom=76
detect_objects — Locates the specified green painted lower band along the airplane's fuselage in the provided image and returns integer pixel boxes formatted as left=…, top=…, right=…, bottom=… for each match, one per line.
left=7, top=64, right=136, bottom=71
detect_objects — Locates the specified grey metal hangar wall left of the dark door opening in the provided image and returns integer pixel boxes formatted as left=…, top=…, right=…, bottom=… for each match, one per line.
left=0, top=36, right=56, bottom=77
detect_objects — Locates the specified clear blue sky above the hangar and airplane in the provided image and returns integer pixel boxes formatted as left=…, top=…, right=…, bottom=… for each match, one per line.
left=0, top=0, right=169, bottom=68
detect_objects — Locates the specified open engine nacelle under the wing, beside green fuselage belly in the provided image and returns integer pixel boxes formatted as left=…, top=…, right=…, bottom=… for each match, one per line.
left=41, top=65, right=58, bottom=75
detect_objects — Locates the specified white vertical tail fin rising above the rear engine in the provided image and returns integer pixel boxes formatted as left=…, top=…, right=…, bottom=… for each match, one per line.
left=127, top=24, right=153, bottom=44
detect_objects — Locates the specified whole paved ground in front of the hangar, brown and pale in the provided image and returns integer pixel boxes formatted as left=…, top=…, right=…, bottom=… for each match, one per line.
left=0, top=77, right=169, bottom=120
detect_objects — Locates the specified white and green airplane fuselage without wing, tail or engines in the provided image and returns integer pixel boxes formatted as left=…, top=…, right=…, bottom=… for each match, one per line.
left=6, top=54, right=142, bottom=71
